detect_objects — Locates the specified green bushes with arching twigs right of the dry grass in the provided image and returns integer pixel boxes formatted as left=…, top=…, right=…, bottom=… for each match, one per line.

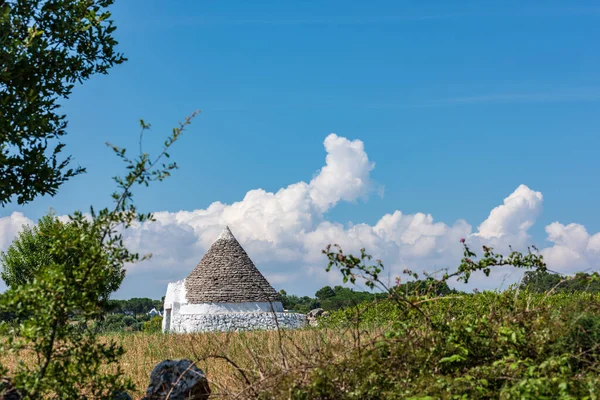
left=261, top=246, right=600, bottom=400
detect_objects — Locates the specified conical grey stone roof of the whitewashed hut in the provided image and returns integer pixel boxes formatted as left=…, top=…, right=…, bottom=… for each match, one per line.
left=185, top=227, right=280, bottom=304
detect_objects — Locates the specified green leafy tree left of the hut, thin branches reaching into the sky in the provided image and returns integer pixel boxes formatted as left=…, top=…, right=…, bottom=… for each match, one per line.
left=0, top=114, right=195, bottom=400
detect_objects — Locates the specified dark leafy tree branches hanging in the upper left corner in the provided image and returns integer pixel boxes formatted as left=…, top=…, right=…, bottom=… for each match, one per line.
left=0, top=0, right=125, bottom=206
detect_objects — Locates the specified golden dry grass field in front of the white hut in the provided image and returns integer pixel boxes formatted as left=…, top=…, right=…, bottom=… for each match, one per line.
left=0, top=329, right=364, bottom=399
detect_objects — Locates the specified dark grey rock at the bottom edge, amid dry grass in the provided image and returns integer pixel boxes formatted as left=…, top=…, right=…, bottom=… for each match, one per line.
left=142, top=359, right=210, bottom=400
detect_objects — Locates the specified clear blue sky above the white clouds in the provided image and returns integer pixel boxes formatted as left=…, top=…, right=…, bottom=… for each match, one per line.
left=0, top=0, right=600, bottom=297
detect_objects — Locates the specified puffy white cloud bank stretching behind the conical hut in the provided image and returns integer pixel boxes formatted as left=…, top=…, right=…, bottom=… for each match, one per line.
left=0, top=134, right=600, bottom=298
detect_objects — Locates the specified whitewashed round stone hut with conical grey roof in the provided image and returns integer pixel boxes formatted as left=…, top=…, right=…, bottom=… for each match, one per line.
left=162, top=227, right=306, bottom=332
